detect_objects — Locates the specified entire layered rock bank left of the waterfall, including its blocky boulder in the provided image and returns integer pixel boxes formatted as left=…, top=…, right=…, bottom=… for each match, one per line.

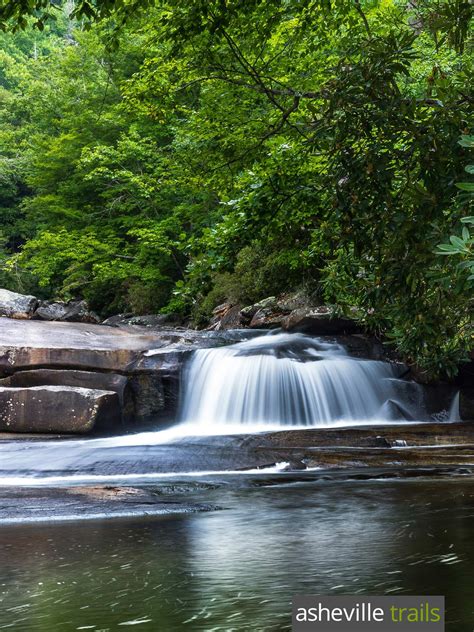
left=0, top=318, right=212, bottom=433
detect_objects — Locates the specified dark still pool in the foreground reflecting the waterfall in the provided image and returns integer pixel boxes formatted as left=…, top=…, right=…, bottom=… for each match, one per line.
left=0, top=478, right=474, bottom=632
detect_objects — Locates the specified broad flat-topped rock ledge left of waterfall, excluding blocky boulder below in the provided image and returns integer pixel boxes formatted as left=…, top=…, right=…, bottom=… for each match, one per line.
left=0, top=318, right=239, bottom=432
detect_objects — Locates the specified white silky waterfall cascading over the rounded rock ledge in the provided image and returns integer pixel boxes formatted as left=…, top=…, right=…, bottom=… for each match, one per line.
left=181, top=333, right=426, bottom=432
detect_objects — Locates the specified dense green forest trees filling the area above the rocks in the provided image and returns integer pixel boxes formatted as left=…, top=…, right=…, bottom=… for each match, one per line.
left=0, top=0, right=474, bottom=374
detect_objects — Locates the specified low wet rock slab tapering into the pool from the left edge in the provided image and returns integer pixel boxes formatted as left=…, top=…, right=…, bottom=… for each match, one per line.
left=0, top=486, right=218, bottom=525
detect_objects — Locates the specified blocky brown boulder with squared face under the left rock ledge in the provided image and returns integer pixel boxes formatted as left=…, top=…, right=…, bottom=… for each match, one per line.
left=0, top=386, right=120, bottom=433
